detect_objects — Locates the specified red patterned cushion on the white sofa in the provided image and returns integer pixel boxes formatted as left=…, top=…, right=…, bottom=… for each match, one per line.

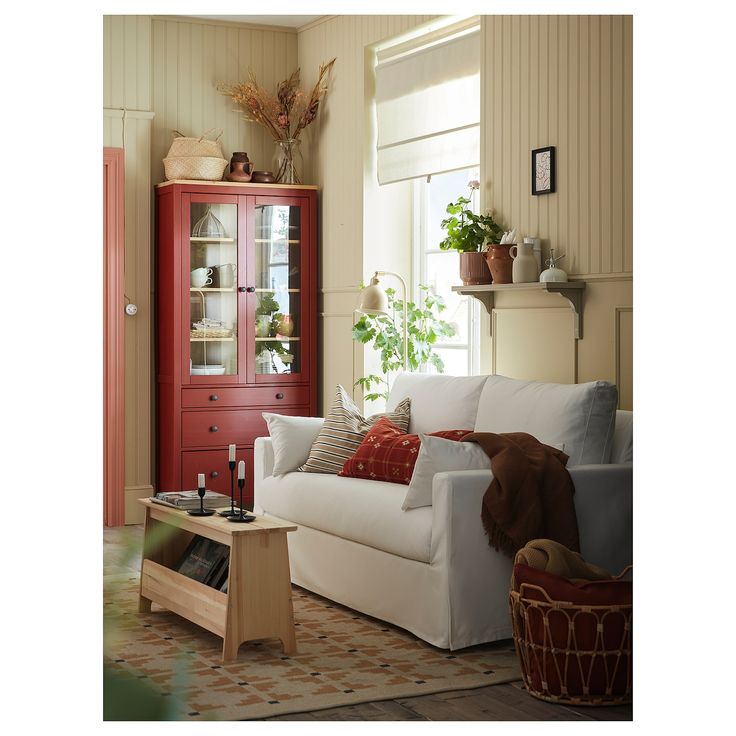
left=338, top=417, right=473, bottom=485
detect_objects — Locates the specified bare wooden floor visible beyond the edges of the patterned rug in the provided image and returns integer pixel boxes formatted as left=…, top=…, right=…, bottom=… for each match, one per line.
left=103, top=525, right=632, bottom=721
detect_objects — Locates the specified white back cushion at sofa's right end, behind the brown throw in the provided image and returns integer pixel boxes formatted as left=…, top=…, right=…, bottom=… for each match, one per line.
left=475, top=376, right=618, bottom=467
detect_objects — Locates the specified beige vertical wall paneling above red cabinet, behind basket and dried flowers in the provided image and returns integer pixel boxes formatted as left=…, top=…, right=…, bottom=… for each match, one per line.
left=151, top=16, right=298, bottom=183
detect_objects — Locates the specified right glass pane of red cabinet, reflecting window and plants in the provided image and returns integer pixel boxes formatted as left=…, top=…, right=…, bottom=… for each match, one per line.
left=255, top=200, right=306, bottom=380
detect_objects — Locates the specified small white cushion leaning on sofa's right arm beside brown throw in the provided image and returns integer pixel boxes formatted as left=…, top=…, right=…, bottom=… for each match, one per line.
left=401, top=434, right=491, bottom=511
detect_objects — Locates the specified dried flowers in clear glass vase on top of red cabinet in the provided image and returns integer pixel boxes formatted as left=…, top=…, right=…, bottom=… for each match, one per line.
left=217, top=59, right=335, bottom=184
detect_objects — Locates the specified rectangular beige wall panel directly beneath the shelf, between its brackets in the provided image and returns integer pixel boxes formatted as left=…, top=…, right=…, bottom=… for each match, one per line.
left=491, top=307, right=576, bottom=383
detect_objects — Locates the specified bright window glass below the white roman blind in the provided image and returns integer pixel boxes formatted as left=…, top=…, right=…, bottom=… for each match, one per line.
left=414, top=168, right=480, bottom=376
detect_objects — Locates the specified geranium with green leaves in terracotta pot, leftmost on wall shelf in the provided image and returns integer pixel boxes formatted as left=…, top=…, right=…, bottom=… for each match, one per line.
left=440, top=180, right=504, bottom=286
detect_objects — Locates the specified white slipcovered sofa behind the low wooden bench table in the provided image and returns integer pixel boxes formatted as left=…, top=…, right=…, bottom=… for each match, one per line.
left=254, top=374, right=632, bottom=650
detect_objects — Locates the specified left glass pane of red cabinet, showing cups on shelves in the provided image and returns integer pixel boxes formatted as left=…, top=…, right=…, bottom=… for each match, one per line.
left=187, top=196, right=238, bottom=382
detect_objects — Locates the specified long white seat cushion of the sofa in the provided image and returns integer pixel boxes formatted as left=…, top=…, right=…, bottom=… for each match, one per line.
left=258, top=473, right=432, bottom=564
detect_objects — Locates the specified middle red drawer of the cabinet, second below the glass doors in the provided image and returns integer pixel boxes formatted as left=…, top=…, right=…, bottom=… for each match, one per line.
left=181, top=406, right=309, bottom=447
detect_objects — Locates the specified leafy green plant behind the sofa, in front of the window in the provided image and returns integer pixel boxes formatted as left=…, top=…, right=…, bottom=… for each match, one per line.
left=353, top=285, right=455, bottom=401
